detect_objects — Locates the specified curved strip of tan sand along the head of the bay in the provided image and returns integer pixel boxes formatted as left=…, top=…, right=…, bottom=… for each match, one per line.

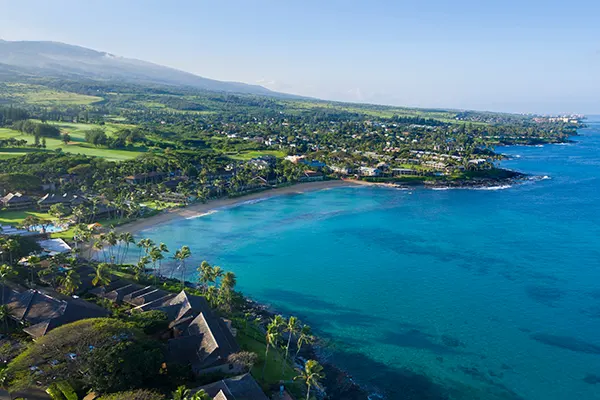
left=115, top=180, right=357, bottom=234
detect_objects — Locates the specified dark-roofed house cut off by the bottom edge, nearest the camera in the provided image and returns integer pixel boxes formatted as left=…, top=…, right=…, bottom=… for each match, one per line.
left=192, top=374, right=269, bottom=400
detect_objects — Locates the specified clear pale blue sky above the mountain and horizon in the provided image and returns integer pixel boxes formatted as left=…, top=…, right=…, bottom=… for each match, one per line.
left=0, top=0, right=600, bottom=114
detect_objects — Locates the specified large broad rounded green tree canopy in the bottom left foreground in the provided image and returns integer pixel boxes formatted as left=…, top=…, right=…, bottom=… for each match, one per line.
left=8, top=318, right=163, bottom=393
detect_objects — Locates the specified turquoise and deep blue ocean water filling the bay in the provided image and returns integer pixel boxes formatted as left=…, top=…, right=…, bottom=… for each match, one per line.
left=141, top=119, right=600, bottom=400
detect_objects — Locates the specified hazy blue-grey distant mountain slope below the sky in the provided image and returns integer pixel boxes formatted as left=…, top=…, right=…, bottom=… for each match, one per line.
left=0, top=40, right=288, bottom=97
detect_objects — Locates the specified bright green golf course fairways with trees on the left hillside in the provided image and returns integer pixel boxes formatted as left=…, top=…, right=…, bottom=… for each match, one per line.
left=0, top=124, right=146, bottom=161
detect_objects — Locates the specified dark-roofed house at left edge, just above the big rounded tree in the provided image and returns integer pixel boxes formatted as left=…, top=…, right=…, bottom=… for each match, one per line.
left=2, top=288, right=108, bottom=339
